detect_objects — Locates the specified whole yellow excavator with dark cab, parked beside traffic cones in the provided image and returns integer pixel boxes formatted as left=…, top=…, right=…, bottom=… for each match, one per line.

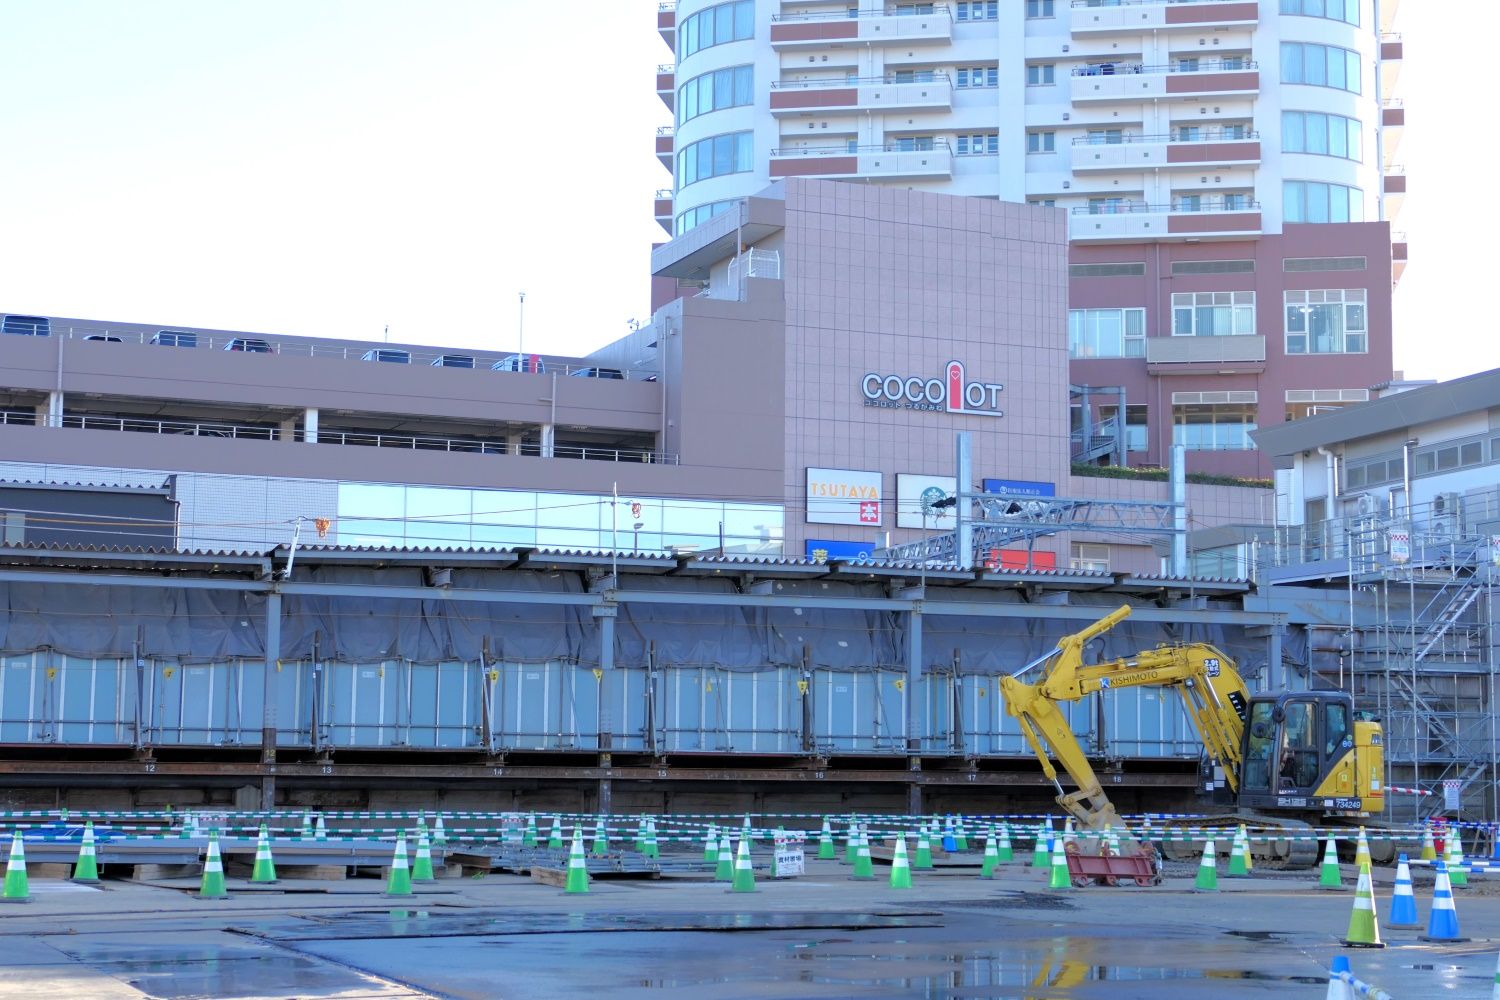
left=1001, top=604, right=1385, bottom=867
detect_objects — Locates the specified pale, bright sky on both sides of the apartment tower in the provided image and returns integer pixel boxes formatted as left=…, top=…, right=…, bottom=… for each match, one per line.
left=0, top=0, right=1482, bottom=378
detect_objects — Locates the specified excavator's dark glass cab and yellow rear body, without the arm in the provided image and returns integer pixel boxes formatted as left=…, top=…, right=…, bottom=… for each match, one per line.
left=1239, top=691, right=1383, bottom=813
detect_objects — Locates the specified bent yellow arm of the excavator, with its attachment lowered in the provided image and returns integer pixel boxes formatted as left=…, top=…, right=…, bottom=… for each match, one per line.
left=1001, top=604, right=1250, bottom=831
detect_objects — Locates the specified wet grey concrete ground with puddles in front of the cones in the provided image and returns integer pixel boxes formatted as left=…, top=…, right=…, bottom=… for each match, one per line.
left=0, top=861, right=1500, bottom=1000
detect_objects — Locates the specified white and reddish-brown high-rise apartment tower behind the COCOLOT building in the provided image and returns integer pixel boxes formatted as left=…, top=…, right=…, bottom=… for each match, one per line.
left=656, top=0, right=1406, bottom=474
